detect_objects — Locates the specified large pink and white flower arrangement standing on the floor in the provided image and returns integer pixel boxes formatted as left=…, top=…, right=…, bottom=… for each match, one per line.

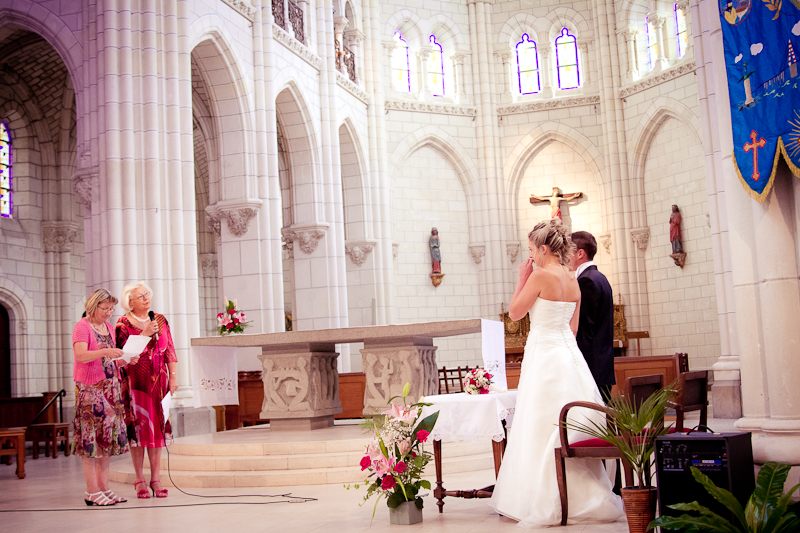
left=345, top=383, right=439, bottom=518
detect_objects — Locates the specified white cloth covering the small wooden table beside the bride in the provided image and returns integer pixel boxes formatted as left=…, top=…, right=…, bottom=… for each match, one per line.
left=420, top=391, right=517, bottom=442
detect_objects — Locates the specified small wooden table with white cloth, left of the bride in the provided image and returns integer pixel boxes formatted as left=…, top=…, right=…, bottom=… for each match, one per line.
left=420, top=391, right=517, bottom=513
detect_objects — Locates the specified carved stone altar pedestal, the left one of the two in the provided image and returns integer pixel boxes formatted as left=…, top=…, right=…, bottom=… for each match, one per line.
left=258, top=350, right=342, bottom=429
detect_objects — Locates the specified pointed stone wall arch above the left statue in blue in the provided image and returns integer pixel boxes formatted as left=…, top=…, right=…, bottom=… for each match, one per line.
left=389, top=125, right=479, bottom=242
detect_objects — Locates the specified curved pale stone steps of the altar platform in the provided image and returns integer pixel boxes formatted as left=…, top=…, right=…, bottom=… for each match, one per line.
left=110, top=426, right=494, bottom=488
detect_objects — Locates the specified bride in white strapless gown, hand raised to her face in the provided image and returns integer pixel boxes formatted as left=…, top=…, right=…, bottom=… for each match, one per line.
left=490, top=219, right=624, bottom=527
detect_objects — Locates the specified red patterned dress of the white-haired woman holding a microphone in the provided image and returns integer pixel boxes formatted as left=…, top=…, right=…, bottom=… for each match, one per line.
left=116, top=313, right=178, bottom=448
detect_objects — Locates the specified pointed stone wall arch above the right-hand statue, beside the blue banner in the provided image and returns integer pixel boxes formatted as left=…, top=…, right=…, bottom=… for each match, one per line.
left=628, top=96, right=703, bottom=227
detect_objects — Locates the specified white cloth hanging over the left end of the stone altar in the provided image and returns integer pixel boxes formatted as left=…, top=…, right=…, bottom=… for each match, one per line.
left=192, top=346, right=239, bottom=407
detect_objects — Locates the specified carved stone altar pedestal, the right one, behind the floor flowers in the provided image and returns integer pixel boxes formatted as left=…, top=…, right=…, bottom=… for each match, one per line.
left=361, top=339, right=439, bottom=417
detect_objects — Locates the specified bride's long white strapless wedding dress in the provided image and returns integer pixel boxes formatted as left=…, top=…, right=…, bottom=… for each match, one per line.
left=490, top=298, right=625, bottom=527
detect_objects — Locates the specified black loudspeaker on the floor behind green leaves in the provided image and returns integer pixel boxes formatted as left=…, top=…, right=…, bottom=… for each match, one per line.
left=656, top=433, right=755, bottom=524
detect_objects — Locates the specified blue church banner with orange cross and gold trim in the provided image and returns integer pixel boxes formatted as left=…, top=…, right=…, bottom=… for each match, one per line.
left=718, top=0, right=800, bottom=202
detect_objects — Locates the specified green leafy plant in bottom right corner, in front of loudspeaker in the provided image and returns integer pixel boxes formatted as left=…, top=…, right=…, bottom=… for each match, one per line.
left=648, top=462, right=800, bottom=533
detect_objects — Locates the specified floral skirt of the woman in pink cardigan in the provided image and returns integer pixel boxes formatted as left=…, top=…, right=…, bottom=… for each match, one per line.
left=72, top=378, right=128, bottom=457
